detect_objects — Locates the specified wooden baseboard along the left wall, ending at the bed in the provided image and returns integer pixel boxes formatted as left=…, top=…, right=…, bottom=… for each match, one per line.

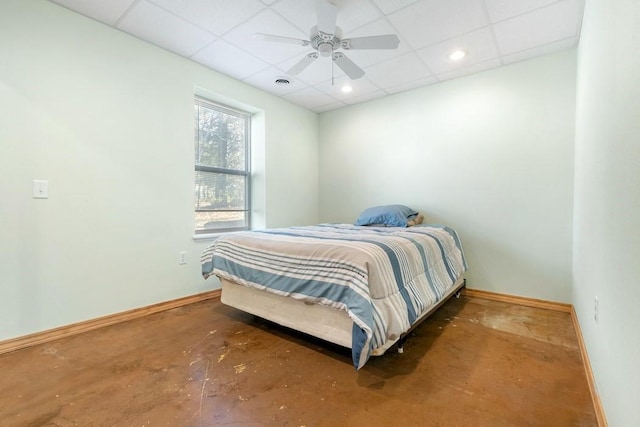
left=0, top=289, right=220, bottom=354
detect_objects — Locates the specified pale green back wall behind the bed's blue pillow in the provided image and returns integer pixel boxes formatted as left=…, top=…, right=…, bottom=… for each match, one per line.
left=320, top=49, right=576, bottom=302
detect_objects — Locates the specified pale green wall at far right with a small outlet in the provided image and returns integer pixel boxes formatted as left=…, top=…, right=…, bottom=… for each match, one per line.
left=572, top=0, right=640, bottom=426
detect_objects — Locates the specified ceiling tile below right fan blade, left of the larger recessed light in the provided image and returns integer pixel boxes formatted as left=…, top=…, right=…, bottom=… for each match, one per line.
left=365, top=53, right=431, bottom=89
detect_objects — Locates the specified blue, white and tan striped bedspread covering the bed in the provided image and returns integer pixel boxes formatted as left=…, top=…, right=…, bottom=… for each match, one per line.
left=201, top=224, right=467, bottom=369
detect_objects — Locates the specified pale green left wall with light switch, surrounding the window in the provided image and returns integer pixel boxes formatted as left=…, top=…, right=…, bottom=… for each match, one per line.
left=0, top=0, right=318, bottom=340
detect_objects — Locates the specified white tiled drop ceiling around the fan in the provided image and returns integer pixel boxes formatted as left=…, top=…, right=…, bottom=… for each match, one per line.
left=50, top=0, right=585, bottom=112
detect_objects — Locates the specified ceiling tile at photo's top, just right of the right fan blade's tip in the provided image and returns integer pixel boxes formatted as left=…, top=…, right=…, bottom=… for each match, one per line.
left=389, top=0, right=488, bottom=49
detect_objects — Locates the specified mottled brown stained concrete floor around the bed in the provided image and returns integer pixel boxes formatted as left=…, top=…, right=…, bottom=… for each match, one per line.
left=0, top=296, right=597, bottom=427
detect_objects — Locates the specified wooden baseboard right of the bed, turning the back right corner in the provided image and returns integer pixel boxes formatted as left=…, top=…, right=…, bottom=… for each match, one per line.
left=464, top=288, right=608, bottom=427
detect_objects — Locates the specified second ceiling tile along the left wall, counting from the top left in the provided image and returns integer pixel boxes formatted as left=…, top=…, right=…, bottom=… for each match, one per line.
left=117, top=1, right=215, bottom=56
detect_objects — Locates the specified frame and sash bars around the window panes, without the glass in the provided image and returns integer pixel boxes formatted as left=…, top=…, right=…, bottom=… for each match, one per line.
left=193, top=95, right=252, bottom=238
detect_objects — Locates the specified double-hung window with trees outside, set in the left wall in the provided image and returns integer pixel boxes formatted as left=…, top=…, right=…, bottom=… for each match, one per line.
left=195, top=97, right=251, bottom=234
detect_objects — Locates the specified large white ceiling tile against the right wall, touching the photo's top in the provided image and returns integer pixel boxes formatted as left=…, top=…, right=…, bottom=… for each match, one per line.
left=494, top=0, right=584, bottom=55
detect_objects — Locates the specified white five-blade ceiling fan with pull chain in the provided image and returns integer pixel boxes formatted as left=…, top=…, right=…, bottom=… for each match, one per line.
left=255, top=0, right=400, bottom=84
